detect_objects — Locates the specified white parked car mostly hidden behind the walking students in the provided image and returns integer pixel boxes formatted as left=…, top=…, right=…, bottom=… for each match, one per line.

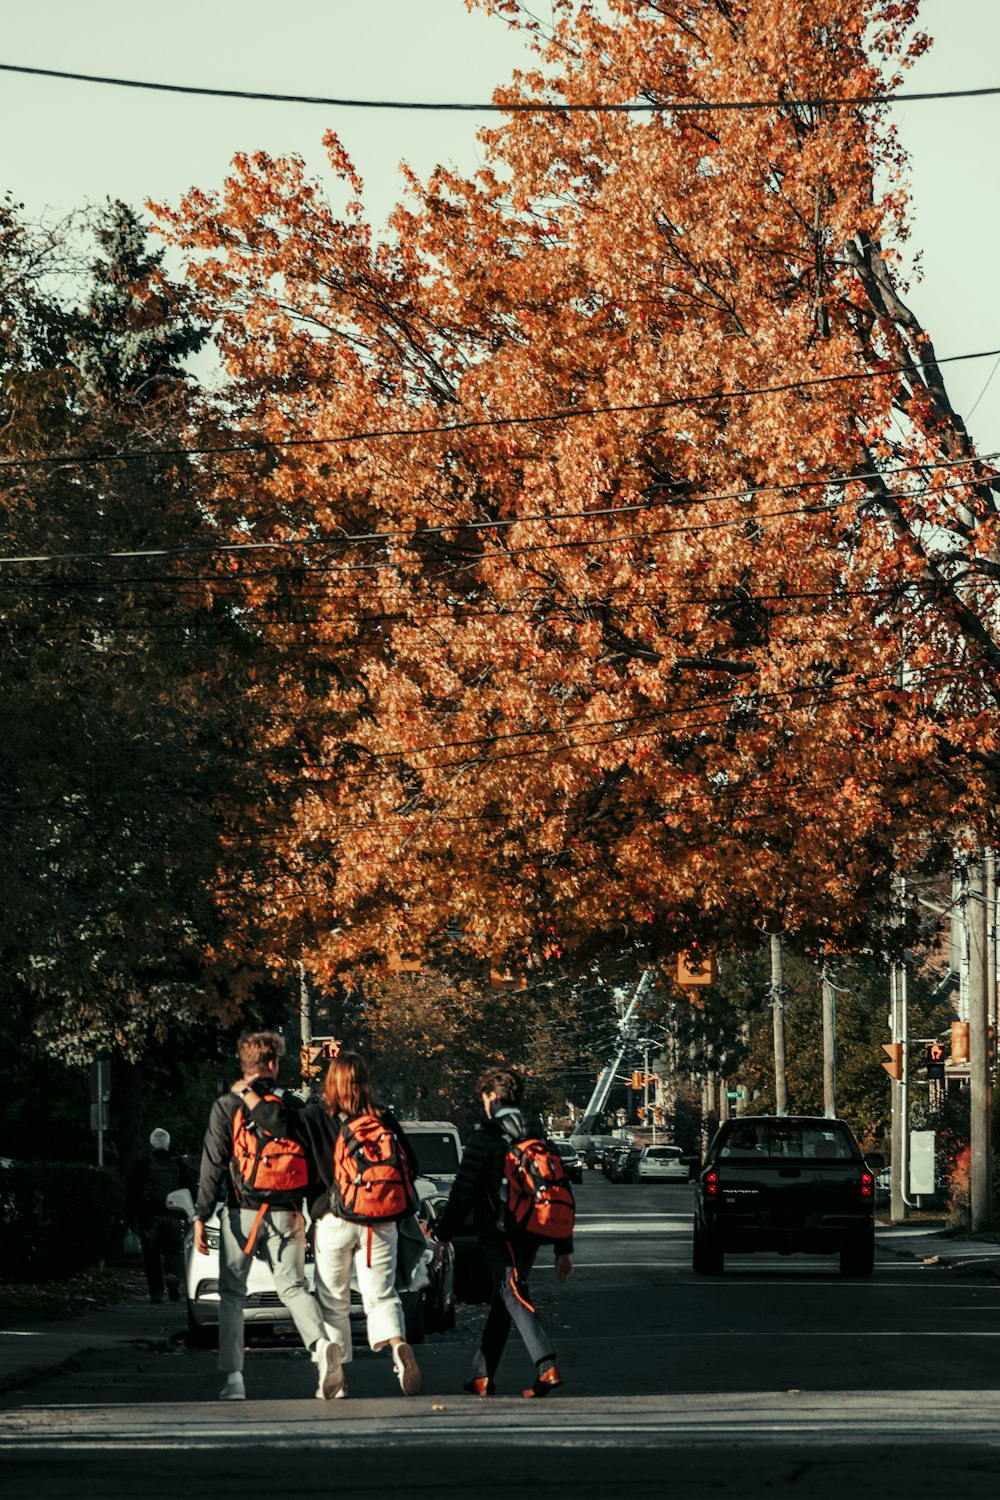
left=166, top=1178, right=454, bottom=1349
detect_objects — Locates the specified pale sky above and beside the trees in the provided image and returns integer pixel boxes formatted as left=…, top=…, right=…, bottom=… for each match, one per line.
left=0, top=0, right=1000, bottom=453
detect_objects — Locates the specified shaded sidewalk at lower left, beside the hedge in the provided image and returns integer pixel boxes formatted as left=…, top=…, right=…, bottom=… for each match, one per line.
left=0, top=1301, right=177, bottom=1392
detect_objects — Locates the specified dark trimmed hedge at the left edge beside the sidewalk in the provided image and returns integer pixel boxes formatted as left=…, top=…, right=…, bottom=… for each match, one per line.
left=0, top=1161, right=123, bottom=1281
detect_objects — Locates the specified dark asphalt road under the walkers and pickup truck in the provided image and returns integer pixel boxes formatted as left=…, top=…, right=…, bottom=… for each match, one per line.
left=0, top=1173, right=1000, bottom=1500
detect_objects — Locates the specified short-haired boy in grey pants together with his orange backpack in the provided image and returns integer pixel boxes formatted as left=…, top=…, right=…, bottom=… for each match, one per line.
left=195, top=1032, right=343, bottom=1401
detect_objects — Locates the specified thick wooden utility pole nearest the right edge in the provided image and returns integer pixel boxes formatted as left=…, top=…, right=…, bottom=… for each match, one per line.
left=966, top=858, right=993, bottom=1233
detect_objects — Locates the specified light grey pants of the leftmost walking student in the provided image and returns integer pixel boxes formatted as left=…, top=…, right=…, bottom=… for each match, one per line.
left=219, top=1209, right=325, bottom=1374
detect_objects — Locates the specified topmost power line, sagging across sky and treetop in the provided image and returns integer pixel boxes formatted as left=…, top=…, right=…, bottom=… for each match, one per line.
left=0, top=63, right=1000, bottom=114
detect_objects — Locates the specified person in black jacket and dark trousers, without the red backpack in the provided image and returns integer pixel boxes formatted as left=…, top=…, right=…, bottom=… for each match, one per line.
left=435, top=1064, right=573, bottom=1397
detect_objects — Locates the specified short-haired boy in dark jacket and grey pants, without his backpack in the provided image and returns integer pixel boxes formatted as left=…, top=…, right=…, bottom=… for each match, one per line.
left=195, top=1032, right=340, bottom=1401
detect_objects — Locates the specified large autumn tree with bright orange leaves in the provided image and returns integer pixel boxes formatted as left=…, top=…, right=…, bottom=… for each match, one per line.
left=159, top=0, right=1000, bottom=980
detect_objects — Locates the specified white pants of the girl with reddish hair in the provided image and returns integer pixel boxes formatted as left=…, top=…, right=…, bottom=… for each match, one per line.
left=313, top=1214, right=405, bottom=1364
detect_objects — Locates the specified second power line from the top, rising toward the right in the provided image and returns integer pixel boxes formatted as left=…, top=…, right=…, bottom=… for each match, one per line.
left=0, top=350, right=1000, bottom=480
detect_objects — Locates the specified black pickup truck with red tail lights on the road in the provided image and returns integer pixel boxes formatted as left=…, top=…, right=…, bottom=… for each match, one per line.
left=691, top=1116, right=885, bottom=1277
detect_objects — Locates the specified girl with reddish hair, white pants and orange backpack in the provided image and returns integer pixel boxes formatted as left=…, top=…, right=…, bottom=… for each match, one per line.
left=256, top=1052, right=421, bottom=1397
